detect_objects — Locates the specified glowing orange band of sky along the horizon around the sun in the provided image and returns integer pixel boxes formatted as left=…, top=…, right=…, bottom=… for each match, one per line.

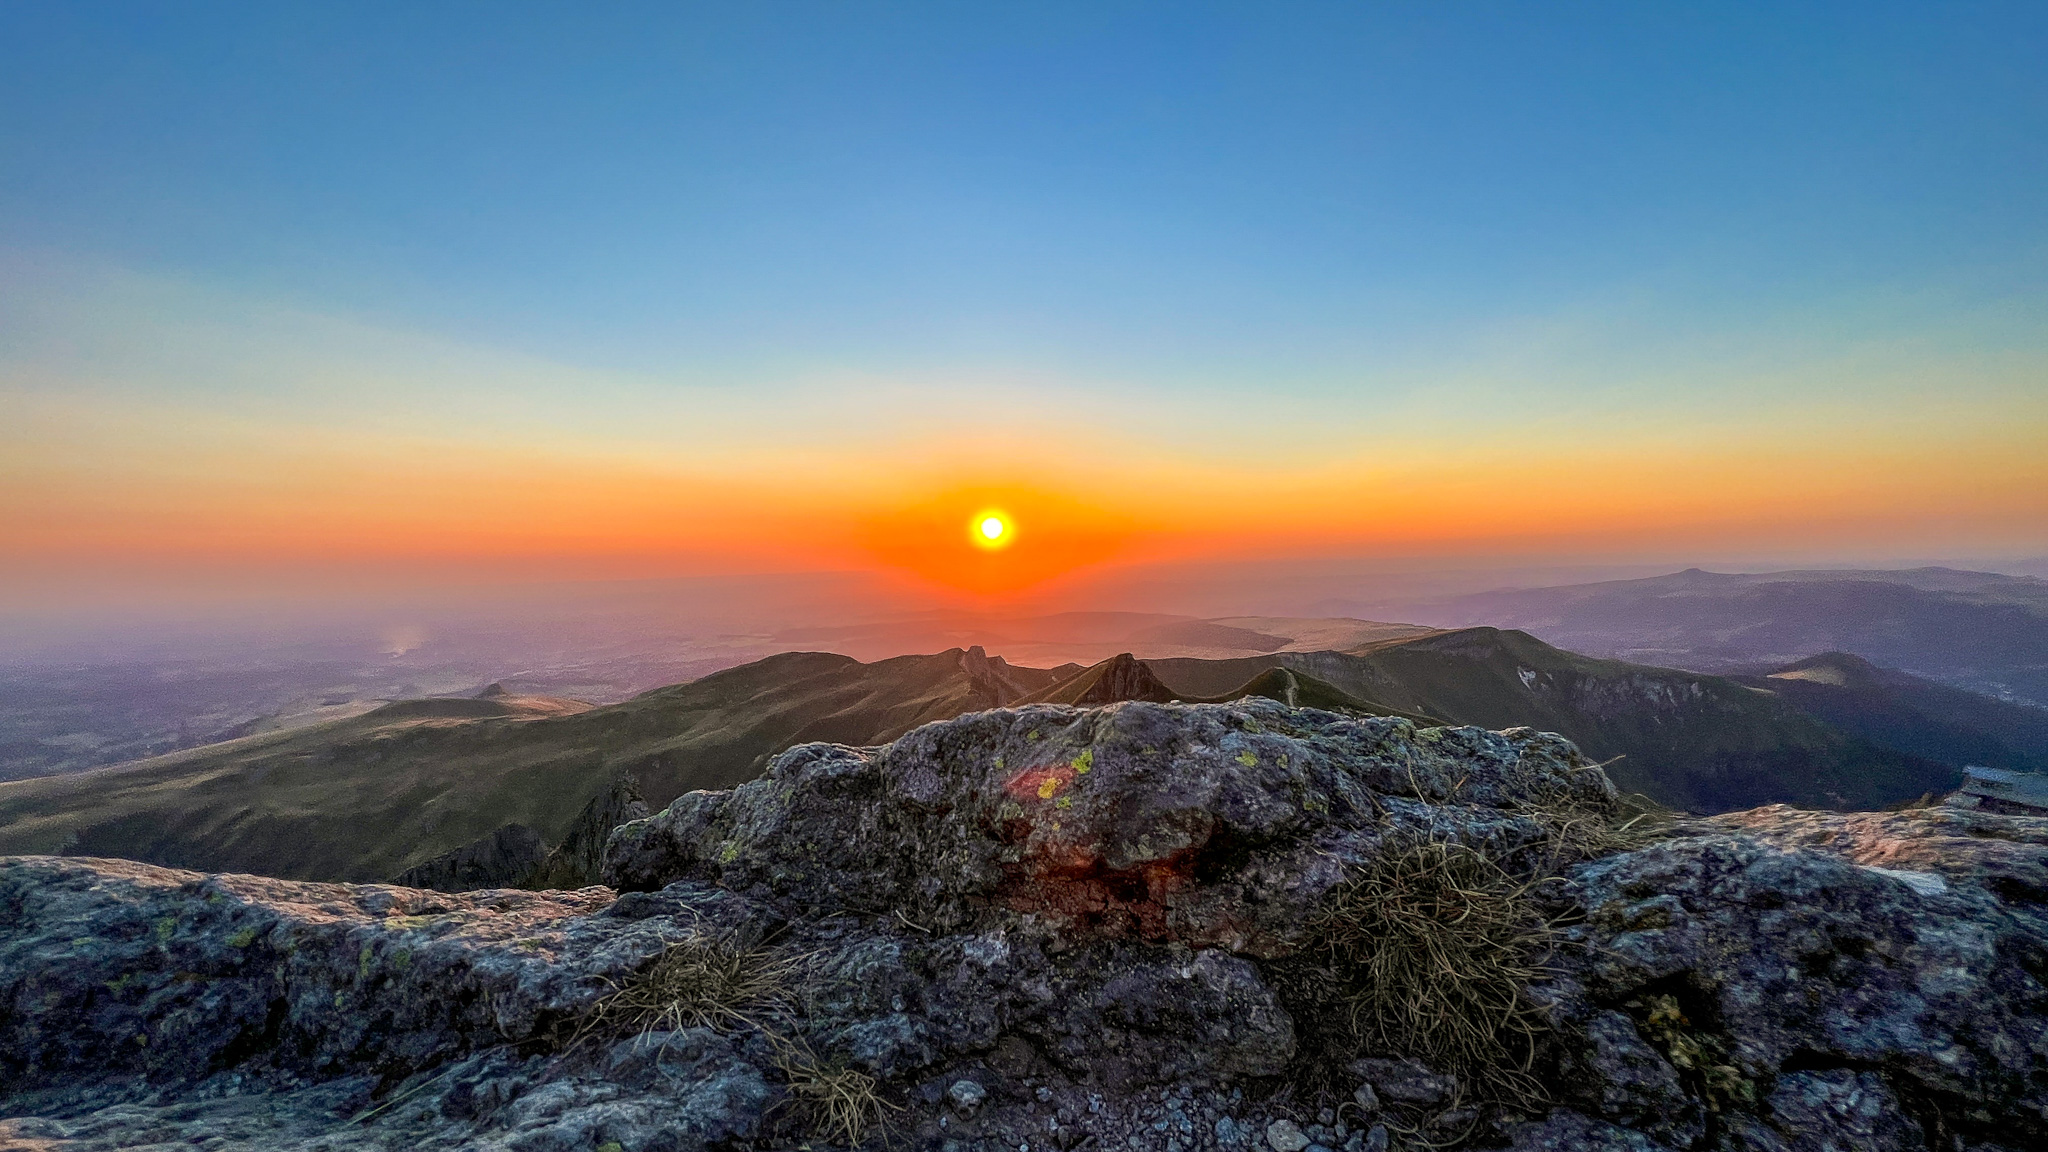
left=0, top=385, right=2048, bottom=601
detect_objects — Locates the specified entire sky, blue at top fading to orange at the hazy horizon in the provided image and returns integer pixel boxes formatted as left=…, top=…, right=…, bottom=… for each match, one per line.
left=0, top=2, right=2048, bottom=601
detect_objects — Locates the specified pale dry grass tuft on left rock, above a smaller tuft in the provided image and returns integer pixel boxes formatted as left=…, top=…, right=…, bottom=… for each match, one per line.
left=590, top=935, right=805, bottom=1035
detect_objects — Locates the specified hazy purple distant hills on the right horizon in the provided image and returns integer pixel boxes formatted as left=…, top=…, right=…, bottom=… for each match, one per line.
left=1405, top=568, right=2048, bottom=707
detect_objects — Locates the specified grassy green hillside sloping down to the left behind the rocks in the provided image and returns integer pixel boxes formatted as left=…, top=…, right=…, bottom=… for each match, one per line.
left=0, top=650, right=1053, bottom=881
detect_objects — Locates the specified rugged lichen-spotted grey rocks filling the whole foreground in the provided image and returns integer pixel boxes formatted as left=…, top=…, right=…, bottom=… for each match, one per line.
left=0, top=701, right=2048, bottom=1152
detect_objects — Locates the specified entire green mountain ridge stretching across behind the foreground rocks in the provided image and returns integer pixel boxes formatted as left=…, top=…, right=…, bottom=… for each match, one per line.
left=0, top=621, right=2036, bottom=879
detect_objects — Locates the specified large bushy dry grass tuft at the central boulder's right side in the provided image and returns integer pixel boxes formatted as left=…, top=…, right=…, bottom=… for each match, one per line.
left=1309, top=840, right=1552, bottom=1078
